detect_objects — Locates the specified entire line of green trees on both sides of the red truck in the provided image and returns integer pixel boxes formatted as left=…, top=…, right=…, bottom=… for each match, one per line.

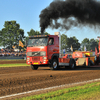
left=0, top=21, right=98, bottom=51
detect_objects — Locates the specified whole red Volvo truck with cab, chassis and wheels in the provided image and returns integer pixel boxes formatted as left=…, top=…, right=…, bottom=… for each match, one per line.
left=26, top=32, right=76, bottom=70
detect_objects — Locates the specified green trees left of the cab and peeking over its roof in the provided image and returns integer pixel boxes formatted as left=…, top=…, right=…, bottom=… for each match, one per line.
left=0, top=21, right=49, bottom=49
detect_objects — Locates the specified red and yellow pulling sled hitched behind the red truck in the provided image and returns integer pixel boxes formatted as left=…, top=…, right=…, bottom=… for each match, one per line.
left=72, top=36, right=100, bottom=67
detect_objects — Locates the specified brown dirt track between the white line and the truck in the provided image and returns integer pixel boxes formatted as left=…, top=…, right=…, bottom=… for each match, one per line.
left=0, top=64, right=100, bottom=99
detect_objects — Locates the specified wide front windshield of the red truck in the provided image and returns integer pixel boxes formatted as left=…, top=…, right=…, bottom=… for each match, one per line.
left=27, top=37, right=48, bottom=47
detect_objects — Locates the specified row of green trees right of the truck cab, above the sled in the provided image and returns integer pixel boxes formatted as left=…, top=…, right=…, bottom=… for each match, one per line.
left=61, top=34, right=99, bottom=51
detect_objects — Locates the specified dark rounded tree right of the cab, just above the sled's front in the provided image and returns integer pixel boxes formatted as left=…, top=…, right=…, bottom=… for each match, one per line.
left=67, top=36, right=80, bottom=51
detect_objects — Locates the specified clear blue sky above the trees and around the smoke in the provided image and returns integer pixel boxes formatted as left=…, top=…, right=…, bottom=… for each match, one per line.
left=0, top=0, right=100, bottom=46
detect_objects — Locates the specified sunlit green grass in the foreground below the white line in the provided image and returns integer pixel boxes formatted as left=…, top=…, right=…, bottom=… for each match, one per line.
left=15, top=82, right=100, bottom=100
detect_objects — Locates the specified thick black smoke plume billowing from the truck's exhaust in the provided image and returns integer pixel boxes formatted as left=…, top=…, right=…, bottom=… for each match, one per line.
left=39, top=0, right=100, bottom=34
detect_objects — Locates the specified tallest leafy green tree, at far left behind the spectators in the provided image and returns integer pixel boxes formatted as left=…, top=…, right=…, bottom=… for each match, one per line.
left=0, top=21, right=24, bottom=48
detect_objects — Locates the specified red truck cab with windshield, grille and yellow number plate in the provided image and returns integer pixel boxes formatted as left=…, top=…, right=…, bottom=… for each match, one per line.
left=26, top=35, right=59, bottom=69
